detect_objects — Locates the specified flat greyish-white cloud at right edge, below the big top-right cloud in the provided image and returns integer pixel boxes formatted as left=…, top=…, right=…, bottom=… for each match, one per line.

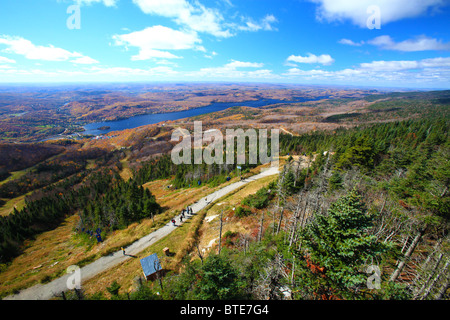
left=368, top=35, right=450, bottom=52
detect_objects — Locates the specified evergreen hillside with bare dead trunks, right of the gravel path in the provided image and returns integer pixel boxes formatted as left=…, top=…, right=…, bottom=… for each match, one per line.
left=58, top=119, right=450, bottom=300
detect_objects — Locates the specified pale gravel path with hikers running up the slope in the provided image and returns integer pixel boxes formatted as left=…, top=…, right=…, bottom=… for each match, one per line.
left=4, top=167, right=279, bottom=300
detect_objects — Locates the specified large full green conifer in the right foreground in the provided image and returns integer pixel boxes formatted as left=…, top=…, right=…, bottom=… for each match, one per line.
left=300, top=190, right=388, bottom=299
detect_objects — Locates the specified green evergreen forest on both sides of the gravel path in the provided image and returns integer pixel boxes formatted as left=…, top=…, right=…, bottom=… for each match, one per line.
left=0, top=95, right=450, bottom=300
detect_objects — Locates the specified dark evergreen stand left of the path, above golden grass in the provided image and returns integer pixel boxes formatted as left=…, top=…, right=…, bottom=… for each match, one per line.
left=0, top=168, right=161, bottom=263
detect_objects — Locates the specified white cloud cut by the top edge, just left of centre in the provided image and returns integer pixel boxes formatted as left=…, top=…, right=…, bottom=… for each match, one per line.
left=133, top=0, right=232, bottom=38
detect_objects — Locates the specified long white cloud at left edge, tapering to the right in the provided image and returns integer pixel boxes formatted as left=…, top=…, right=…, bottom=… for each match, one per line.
left=0, top=35, right=95, bottom=63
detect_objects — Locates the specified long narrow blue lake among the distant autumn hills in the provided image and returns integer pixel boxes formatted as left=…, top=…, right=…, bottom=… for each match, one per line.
left=82, top=97, right=325, bottom=135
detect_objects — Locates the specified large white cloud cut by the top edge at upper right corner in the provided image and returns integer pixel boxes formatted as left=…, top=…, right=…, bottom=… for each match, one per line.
left=309, top=0, right=448, bottom=28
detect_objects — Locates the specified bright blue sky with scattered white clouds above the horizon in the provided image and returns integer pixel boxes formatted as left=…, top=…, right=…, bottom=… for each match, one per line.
left=0, top=0, right=450, bottom=88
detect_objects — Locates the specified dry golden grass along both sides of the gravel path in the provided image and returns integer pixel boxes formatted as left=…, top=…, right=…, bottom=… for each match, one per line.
left=0, top=161, right=282, bottom=296
